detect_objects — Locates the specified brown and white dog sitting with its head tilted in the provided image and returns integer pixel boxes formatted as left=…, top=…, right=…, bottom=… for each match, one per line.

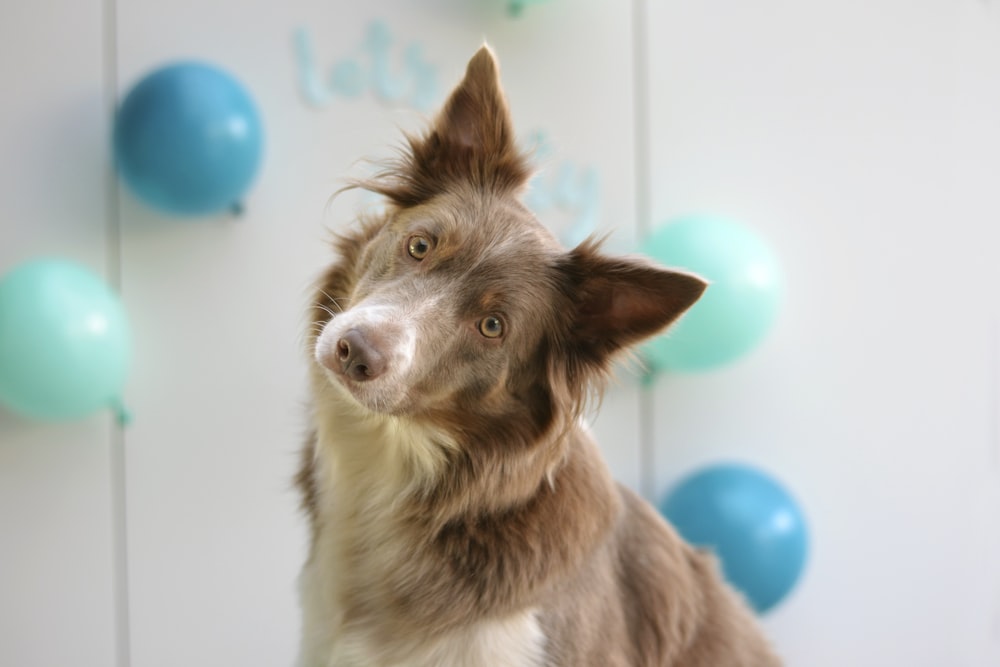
left=297, top=47, right=780, bottom=667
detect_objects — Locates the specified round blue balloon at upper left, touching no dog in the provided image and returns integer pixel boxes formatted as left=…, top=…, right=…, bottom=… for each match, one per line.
left=114, top=62, right=263, bottom=215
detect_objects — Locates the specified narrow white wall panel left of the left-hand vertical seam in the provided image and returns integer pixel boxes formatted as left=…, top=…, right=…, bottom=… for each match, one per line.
left=0, top=0, right=117, bottom=667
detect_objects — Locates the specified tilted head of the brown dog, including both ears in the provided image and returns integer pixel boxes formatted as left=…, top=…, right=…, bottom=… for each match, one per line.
left=310, top=47, right=705, bottom=482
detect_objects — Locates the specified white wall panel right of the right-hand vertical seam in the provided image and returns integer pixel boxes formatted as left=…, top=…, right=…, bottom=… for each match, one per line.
left=648, top=0, right=1000, bottom=666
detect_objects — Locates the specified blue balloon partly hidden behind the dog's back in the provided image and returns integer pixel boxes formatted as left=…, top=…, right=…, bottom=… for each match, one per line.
left=660, top=464, right=809, bottom=612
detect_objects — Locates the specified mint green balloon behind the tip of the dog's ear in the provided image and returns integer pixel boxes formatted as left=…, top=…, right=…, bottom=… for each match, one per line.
left=641, top=216, right=784, bottom=371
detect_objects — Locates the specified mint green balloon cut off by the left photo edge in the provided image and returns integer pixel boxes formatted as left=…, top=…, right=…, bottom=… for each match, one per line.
left=0, top=259, right=132, bottom=420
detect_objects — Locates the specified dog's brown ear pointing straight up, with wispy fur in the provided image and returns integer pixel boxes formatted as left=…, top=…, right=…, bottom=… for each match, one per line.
left=364, top=45, right=531, bottom=206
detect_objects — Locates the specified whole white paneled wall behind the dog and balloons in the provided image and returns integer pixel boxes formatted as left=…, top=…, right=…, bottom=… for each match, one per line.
left=0, top=0, right=1000, bottom=667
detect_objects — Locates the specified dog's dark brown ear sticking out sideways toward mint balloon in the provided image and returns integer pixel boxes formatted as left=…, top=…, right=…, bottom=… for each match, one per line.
left=566, top=242, right=708, bottom=361
